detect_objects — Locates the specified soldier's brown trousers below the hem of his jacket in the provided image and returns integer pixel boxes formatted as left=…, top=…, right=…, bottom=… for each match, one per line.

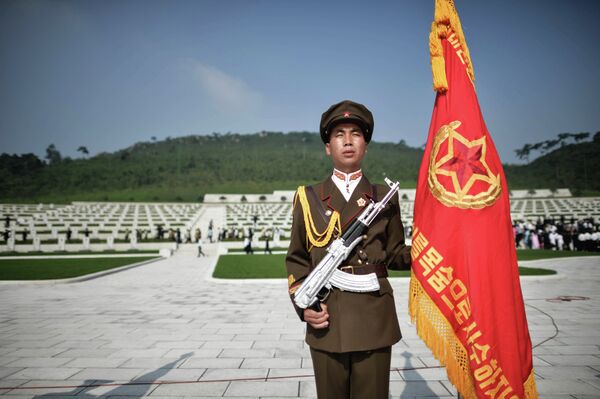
left=310, top=346, right=392, bottom=399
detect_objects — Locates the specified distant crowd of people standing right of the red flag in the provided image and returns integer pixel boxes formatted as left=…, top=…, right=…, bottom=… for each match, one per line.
left=513, top=216, right=600, bottom=251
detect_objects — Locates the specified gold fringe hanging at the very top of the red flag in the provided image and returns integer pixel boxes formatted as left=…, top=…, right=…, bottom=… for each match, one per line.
left=429, top=0, right=475, bottom=93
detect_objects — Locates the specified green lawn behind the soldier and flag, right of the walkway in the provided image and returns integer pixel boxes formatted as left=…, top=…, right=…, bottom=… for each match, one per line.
left=213, top=250, right=600, bottom=278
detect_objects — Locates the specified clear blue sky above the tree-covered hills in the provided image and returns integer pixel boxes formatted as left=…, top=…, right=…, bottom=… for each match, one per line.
left=0, top=0, right=600, bottom=163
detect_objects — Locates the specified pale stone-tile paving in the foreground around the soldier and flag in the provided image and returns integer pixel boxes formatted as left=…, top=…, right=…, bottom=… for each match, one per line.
left=0, top=244, right=600, bottom=399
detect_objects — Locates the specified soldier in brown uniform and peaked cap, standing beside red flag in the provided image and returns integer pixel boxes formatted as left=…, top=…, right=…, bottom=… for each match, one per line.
left=286, top=100, right=411, bottom=399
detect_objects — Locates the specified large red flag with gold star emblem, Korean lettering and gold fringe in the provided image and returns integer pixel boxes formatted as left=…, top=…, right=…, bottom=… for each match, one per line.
left=409, top=0, right=537, bottom=398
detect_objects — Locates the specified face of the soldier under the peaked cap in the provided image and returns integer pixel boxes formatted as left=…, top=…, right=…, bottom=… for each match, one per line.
left=325, top=123, right=367, bottom=173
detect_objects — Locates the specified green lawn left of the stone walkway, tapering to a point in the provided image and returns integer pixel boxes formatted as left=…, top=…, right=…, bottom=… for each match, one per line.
left=0, top=256, right=156, bottom=280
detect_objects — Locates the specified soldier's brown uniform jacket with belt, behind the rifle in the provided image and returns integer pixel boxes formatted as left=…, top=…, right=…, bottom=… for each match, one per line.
left=286, top=176, right=410, bottom=353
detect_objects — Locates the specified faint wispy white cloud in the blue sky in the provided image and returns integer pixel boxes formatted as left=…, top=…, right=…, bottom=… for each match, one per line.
left=187, top=61, right=264, bottom=112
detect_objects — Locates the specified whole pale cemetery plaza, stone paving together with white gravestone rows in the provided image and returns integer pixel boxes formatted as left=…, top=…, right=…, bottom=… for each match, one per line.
left=0, top=190, right=600, bottom=399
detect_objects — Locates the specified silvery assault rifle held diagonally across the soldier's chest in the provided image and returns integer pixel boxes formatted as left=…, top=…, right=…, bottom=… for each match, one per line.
left=294, top=178, right=400, bottom=311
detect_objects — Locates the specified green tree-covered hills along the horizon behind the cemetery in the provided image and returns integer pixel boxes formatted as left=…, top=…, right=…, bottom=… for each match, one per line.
left=0, top=132, right=600, bottom=202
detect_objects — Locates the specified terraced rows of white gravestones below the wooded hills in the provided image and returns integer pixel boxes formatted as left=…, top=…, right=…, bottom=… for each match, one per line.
left=0, top=189, right=600, bottom=252
